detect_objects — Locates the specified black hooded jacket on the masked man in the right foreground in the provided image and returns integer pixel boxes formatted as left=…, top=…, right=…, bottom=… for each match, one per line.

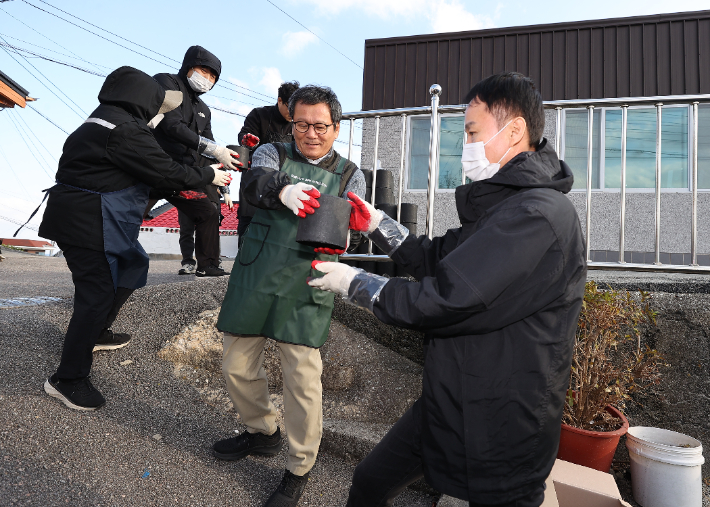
left=373, top=140, right=586, bottom=504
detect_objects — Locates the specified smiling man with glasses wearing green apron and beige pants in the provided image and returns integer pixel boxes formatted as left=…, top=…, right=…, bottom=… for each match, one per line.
left=214, top=86, right=365, bottom=507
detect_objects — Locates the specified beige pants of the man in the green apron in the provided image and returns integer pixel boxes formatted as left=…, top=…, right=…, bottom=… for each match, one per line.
left=222, top=333, right=323, bottom=475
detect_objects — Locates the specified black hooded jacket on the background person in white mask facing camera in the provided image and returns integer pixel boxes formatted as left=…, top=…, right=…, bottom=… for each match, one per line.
left=154, top=46, right=222, bottom=165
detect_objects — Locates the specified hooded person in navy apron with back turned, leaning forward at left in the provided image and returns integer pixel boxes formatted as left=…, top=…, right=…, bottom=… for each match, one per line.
left=39, top=67, right=229, bottom=410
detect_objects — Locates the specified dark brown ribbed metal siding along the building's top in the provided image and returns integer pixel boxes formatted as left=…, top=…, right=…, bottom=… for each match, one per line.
left=362, top=11, right=710, bottom=110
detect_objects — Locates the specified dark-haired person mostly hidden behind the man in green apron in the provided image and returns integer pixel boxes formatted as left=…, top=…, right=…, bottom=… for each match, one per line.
left=237, top=81, right=300, bottom=242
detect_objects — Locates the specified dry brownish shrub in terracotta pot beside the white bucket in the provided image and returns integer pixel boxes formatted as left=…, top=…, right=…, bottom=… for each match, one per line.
left=557, top=281, right=661, bottom=472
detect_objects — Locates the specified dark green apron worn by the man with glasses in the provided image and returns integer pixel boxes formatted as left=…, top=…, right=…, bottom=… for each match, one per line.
left=217, top=145, right=346, bottom=348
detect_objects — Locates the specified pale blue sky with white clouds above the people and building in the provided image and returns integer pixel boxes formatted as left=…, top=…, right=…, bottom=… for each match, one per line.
left=0, top=0, right=709, bottom=239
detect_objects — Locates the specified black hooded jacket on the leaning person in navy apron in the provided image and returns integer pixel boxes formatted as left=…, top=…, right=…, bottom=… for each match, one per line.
left=39, top=67, right=214, bottom=251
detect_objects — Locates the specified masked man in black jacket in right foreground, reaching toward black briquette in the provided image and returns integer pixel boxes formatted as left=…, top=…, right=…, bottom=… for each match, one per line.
left=309, top=73, right=586, bottom=507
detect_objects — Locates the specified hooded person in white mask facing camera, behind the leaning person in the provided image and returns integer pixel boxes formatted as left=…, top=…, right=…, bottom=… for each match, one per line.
left=154, top=46, right=246, bottom=276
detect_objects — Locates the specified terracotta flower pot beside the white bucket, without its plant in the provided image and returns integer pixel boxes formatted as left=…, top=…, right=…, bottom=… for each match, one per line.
left=557, top=405, right=629, bottom=472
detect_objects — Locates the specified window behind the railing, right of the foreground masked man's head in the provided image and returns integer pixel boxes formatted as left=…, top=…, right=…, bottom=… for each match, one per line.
left=562, top=106, right=692, bottom=190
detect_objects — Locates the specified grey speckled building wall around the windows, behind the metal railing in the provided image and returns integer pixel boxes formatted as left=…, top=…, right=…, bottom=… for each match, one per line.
left=360, top=110, right=710, bottom=264
